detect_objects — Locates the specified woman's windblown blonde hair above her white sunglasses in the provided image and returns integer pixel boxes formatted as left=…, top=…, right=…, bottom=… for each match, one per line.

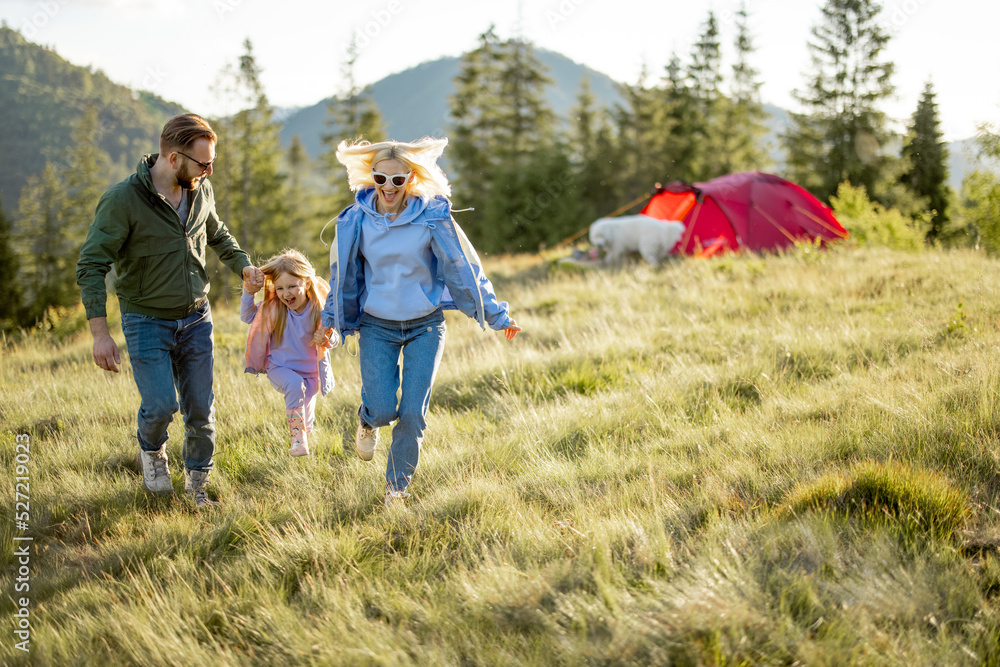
left=337, top=137, right=451, bottom=198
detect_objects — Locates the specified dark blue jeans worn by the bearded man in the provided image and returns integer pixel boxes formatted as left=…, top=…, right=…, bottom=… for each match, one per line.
left=122, top=302, right=215, bottom=472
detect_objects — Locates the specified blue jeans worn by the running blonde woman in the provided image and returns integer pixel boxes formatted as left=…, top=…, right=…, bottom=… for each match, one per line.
left=358, top=310, right=446, bottom=491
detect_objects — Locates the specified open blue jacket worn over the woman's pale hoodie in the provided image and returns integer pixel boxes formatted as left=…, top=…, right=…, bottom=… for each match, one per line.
left=322, top=188, right=510, bottom=342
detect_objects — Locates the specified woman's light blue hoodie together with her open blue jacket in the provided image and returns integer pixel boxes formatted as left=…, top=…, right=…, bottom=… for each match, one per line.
left=322, top=188, right=510, bottom=340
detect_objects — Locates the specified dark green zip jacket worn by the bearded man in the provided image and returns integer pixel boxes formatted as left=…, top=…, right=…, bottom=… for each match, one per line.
left=76, top=153, right=250, bottom=320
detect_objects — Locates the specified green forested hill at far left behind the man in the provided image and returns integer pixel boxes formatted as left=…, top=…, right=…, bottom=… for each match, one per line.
left=0, top=26, right=183, bottom=211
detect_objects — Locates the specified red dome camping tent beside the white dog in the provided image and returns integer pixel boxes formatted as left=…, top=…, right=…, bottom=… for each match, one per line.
left=642, top=171, right=847, bottom=255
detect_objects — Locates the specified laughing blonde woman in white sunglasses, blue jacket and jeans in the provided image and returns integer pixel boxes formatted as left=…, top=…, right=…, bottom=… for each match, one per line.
left=316, top=137, right=521, bottom=505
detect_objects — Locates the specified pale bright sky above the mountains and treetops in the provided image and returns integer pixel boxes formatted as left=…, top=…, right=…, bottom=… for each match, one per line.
left=0, top=0, right=1000, bottom=141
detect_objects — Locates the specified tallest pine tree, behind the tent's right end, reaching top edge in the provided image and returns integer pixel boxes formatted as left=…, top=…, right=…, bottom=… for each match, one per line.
left=785, top=0, right=894, bottom=199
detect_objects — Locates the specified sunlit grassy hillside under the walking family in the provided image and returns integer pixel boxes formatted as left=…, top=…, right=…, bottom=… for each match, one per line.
left=0, top=249, right=1000, bottom=666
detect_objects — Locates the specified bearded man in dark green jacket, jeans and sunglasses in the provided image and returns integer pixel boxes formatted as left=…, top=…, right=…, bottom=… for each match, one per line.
left=76, top=114, right=264, bottom=507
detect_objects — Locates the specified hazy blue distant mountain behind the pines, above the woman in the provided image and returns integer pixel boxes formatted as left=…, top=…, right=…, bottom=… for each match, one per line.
left=281, top=49, right=621, bottom=158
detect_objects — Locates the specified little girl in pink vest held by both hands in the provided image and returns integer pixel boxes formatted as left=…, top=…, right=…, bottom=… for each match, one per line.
left=240, top=249, right=334, bottom=456
